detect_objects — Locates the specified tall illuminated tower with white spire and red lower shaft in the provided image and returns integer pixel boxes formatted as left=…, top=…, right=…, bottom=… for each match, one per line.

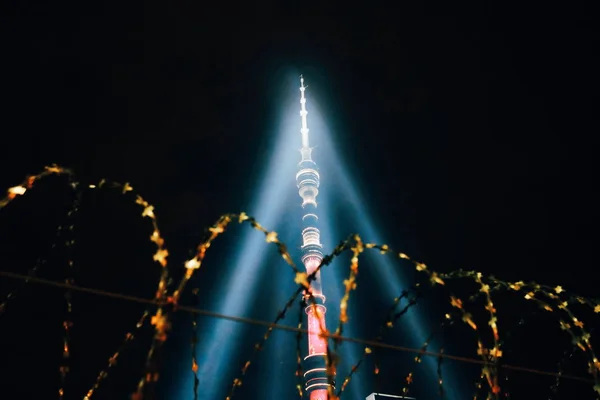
left=296, top=77, right=329, bottom=400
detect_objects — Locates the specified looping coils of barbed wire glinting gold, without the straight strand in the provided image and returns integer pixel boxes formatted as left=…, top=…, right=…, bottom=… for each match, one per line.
left=0, top=165, right=600, bottom=400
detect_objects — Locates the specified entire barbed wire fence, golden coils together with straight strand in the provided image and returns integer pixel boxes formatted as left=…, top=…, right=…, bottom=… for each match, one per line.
left=0, top=165, right=600, bottom=400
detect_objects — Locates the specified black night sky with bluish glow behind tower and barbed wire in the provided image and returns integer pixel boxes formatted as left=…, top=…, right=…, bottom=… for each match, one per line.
left=0, top=1, right=600, bottom=400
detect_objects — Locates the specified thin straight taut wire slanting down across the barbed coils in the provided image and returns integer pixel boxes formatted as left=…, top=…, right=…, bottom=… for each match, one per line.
left=0, top=270, right=593, bottom=383
